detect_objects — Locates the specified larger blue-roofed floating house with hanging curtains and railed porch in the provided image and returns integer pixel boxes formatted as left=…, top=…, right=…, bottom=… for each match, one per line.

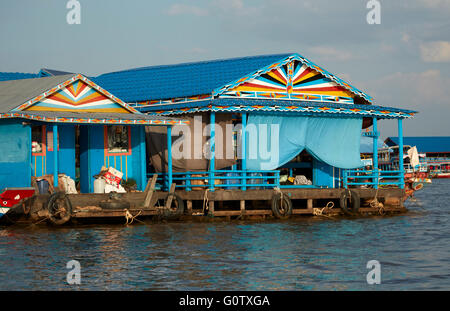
left=94, top=53, right=415, bottom=191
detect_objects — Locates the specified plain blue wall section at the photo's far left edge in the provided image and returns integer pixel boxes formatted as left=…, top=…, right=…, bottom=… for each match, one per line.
left=0, top=120, right=31, bottom=189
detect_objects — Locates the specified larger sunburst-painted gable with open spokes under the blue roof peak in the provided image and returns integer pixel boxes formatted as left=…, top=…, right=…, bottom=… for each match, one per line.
left=220, top=60, right=354, bottom=104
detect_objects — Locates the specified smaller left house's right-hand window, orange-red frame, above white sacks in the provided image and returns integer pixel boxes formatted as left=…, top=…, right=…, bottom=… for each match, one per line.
left=105, top=125, right=131, bottom=155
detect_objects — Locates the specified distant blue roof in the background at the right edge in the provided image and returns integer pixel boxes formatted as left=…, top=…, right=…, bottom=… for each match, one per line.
left=386, top=136, right=450, bottom=152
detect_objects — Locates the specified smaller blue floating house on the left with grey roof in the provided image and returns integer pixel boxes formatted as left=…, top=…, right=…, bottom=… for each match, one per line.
left=0, top=71, right=186, bottom=193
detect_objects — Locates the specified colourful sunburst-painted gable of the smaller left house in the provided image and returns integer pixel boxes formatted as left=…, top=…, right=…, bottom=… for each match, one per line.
left=17, top=75, right=135, bottom=113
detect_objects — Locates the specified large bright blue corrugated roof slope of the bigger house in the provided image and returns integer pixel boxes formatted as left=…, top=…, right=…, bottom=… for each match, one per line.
left=92, top=53, right=292, bottom=103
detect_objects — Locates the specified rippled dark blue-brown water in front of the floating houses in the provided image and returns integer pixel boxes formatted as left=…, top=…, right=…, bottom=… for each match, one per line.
left=0, top=180, right=450, bottom=290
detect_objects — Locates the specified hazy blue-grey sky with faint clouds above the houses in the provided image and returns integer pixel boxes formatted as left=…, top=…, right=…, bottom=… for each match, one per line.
left=0, top=0, right=450, bottom=137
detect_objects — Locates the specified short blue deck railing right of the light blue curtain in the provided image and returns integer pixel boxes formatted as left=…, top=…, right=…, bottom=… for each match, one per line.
left=343, top=169, right=404, bottom=188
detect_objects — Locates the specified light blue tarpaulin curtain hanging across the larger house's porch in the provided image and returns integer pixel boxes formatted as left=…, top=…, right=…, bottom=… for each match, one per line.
left=246, top=115, right=363, bottom=170
